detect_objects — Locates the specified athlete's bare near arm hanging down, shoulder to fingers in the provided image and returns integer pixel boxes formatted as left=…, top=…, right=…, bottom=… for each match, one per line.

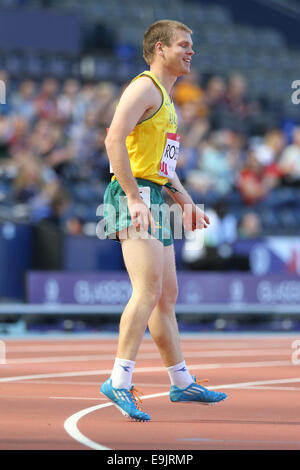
left=105, top=77, right=162, bottom=230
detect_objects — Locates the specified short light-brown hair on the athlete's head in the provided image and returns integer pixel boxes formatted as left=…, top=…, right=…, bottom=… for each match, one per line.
left=143, top=20, right=193, bottom=65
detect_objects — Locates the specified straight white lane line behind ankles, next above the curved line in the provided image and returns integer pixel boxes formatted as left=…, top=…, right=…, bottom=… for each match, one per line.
left=0, top=361, right=292, bottom=383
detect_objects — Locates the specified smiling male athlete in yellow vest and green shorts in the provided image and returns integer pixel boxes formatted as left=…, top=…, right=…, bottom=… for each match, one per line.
left=101, top=20, right=226, bottom=421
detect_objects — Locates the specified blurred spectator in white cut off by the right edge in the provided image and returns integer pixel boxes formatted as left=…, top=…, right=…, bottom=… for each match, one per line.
left=278, top=127, right=300, bottom=187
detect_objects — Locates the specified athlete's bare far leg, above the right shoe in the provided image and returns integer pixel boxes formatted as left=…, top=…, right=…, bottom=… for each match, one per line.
left=148, top=245, right=184, bottom=367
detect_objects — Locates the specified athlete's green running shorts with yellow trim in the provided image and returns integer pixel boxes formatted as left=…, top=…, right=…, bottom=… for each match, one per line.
left=103, top=178, right=173, bottom=246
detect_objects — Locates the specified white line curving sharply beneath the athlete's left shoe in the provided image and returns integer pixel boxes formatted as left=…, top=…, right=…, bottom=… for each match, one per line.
left=64, top=377, right=300, bottom=450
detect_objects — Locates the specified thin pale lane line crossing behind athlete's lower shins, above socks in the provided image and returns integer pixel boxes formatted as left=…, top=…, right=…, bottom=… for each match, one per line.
left=6, top=349, right=291, bottom=365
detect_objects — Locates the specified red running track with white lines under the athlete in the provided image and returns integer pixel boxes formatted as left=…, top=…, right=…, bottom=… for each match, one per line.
left=0, top=334, right=300, bottom=450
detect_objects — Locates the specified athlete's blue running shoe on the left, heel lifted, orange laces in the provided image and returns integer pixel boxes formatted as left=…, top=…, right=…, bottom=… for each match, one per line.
left=100, top=379, right=150, bottom=421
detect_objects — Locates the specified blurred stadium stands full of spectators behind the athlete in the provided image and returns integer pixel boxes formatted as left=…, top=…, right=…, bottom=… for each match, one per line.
left=0, top=0, right=300, bottom=334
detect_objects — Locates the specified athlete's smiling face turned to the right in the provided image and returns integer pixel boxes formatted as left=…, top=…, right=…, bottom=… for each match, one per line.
left=162, top=30, right=195, bottom=77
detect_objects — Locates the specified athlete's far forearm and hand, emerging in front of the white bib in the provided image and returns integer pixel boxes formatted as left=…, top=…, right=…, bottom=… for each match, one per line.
left=167, top=173, right=210, bottom=231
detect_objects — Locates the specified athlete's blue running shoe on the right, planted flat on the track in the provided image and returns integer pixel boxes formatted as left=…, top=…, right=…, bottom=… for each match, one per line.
left=170, top=376, right=227, bottom=405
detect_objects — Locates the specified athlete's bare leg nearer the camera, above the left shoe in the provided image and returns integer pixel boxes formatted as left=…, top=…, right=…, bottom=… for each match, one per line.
left=117, top=233, right=164, bottom=361
